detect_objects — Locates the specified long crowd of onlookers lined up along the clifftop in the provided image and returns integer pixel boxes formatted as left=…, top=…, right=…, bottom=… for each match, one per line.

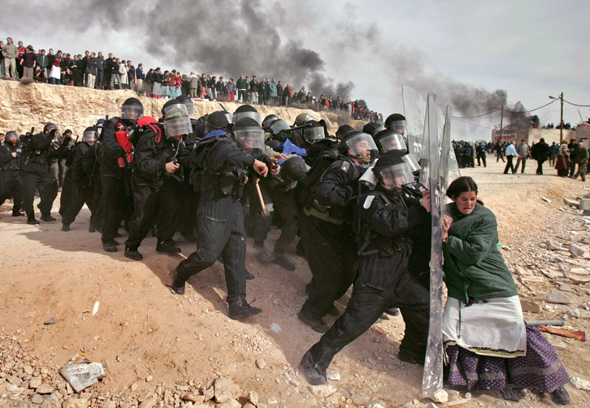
left=0, top=37, right=383, bottom=123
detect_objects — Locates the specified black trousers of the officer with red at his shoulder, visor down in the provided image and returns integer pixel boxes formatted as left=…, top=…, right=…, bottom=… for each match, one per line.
left=125, top=180, right=180, bottom=250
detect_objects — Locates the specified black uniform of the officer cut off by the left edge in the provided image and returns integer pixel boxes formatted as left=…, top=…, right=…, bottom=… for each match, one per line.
left=0, top=142, right=24, bottom=216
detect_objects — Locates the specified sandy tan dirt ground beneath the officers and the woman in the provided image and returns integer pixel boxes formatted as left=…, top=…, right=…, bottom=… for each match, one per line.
left=0, top=156, right=590, bottom=408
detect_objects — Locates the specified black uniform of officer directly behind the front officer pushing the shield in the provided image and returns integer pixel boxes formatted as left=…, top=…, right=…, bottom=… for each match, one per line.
left=300, top=157, right=361, bottom=320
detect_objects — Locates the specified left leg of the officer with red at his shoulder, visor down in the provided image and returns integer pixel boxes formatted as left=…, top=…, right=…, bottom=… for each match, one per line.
left=125, top=184, right=158, bottom=255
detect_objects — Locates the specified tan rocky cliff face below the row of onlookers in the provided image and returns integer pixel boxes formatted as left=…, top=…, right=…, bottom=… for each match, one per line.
left=0, top=80, right=364, bottom=135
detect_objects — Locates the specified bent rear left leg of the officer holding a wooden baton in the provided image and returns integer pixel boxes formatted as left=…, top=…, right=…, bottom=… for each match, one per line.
left=172, top=191, right=233, bottom=294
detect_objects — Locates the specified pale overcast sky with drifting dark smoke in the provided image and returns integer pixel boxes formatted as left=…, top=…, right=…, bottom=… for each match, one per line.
left=0, top=0, right=590, bottom=139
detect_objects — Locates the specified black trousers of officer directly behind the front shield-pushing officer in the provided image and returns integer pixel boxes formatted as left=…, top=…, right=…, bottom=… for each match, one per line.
left=301, top=214, right=357, bottom=320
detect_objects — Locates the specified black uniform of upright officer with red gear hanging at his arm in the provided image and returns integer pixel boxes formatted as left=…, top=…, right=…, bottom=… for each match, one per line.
left=100, top=117, right=133, bottom=247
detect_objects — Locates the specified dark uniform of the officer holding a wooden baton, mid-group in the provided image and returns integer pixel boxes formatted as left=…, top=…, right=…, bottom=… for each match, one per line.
left=172, top=130, right=262, bottom=307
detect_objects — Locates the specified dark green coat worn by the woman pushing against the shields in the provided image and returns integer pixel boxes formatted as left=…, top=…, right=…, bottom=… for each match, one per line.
left=443, top=203, right=518, bottom=302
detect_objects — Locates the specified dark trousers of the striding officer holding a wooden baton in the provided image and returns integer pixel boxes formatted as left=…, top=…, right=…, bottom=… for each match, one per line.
left=174, top=191, right=246, bottom=303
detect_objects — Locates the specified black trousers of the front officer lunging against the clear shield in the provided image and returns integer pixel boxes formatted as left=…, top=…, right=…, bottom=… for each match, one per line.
left=308, top=252, right=430, bottom=371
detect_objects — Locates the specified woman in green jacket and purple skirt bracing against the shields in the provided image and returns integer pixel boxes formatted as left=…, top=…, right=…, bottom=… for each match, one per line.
left=442, top=177, right=571, bottom=405
